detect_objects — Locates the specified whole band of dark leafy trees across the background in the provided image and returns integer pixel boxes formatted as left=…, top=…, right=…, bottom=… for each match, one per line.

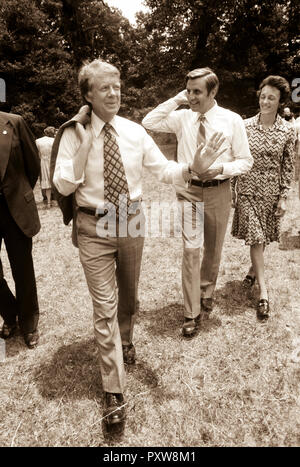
left=0, top=0, right=300, bottom=136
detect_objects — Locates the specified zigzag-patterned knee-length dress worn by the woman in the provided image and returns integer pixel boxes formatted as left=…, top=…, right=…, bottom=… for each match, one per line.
left=231, top=114, right=295, bottom=245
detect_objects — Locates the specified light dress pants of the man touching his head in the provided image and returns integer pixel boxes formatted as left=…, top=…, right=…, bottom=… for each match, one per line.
left=177, top=180, right=231, bottom=318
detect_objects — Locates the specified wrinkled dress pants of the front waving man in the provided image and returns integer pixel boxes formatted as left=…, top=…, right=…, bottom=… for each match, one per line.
left=76, top=211, right=144, bottom=393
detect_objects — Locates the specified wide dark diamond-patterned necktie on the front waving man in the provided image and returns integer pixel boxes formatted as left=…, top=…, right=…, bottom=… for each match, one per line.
left=103, top=123, right=130, bottom=221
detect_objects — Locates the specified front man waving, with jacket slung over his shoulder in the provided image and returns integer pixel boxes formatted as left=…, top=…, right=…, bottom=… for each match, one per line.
left=51, top=60, right=224, bottom=424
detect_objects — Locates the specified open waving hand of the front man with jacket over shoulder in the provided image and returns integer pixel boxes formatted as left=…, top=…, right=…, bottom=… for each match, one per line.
left=191, top=131, right=226, bottom=179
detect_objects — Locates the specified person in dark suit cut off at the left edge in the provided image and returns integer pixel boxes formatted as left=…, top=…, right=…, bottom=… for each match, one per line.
left=0, top=112, right=41, bottom=348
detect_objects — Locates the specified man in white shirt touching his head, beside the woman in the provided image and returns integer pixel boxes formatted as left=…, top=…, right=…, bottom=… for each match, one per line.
left=142, top=68, right=253, bottom=337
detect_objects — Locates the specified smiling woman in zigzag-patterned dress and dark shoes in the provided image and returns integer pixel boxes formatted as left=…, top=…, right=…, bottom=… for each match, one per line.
left=232, top=76, right=295, bottom=320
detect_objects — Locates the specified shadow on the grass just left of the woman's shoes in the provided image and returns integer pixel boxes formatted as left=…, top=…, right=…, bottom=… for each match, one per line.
left=215, top=281, right=257, bottom=315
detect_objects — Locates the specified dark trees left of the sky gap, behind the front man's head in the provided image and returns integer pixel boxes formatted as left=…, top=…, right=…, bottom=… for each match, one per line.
left=0, top=0, right=139, bottom=135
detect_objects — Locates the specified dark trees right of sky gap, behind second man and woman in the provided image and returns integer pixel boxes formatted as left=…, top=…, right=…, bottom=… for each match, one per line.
left=140, top=0, right=300, bottom=113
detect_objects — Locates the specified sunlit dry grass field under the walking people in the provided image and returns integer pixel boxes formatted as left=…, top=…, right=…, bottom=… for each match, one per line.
left=0, top=148, right=300, bottom=447
